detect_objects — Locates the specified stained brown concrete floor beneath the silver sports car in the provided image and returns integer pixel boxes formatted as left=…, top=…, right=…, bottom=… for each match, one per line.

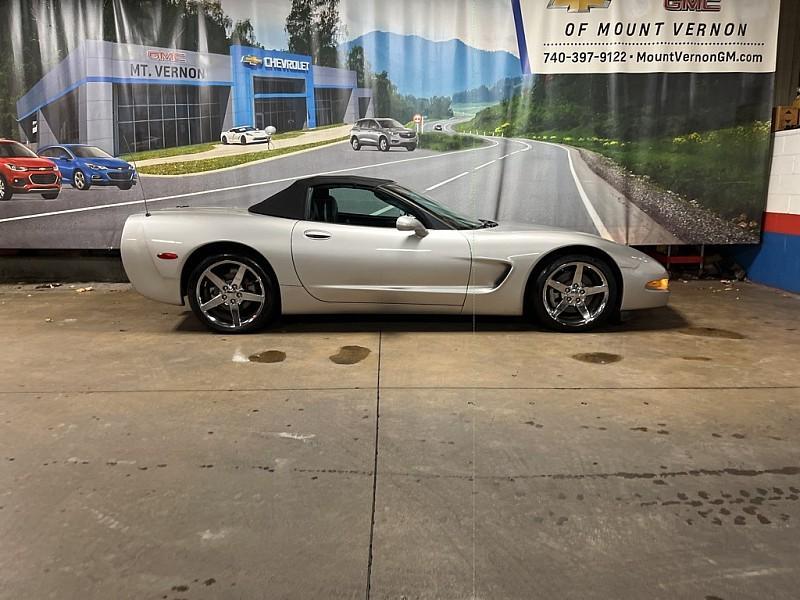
left=0, top=282, right=800, bottom=600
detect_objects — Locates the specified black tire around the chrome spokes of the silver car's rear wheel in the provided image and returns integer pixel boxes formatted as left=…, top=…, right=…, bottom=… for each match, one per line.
left=186, top=253, right=280, bottom=334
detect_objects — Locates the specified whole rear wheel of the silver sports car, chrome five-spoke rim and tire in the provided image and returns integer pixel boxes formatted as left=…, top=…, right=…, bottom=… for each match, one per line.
left=187, top=254, right=280, bottom=333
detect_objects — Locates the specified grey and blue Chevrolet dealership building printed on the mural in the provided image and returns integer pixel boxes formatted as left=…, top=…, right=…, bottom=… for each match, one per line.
left=17, top=40, right=374, bottom=154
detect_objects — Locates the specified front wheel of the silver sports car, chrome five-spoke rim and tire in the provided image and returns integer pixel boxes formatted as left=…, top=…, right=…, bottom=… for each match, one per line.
left=527, top=254, right=620, bottom=333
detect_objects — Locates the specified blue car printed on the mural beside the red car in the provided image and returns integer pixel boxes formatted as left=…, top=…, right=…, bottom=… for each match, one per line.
left=39, top=144, right=136, bottom=190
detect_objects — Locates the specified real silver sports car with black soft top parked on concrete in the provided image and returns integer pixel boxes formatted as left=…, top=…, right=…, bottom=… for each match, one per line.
left=121, top=176, right=669, bottom=333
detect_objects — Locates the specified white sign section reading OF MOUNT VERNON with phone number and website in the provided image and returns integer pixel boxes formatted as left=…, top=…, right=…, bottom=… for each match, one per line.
left=513, top=0, right=780, bottom=74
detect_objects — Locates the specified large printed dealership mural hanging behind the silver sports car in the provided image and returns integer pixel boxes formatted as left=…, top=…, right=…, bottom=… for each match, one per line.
left=0, top=0, right=779, bottom=249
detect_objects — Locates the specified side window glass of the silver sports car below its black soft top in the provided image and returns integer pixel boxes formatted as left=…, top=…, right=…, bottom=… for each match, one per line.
left=310, top=186, right=408, bottom=227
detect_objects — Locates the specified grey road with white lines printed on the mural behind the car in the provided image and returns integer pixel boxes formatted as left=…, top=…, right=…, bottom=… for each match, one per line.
left=0, top=123, right=671, bottom=249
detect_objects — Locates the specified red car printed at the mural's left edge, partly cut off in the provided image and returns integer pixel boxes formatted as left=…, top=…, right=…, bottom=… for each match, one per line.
left=0, top=139, right=61, bottom=200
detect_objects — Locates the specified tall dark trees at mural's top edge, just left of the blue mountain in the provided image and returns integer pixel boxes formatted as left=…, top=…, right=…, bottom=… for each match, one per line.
left=285, top=0, right=341, bottom=67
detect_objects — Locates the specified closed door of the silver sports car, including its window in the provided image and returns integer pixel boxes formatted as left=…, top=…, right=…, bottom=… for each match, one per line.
left=292, top=185, right=471, bottom=307
